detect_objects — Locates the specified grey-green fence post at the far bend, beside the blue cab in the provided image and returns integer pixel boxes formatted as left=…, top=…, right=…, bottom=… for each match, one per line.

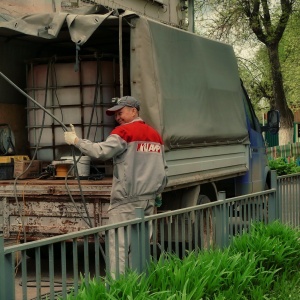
left=268, top=170, right=281, bottom=223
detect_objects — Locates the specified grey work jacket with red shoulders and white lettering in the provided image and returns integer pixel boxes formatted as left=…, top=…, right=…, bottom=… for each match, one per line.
left=75, top=118, right=167, bottom=206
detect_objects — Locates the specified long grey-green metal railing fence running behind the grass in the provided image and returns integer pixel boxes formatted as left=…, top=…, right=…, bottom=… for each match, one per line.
left=0, top=172, right=300, bottom=300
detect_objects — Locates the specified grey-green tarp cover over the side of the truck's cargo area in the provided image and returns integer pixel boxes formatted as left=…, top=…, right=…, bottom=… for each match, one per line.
left=131, top=18, right=248, bottom=149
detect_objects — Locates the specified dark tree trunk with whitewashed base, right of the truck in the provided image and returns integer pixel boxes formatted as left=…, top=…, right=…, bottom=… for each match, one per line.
left=267, top=43, right=294, bottom=145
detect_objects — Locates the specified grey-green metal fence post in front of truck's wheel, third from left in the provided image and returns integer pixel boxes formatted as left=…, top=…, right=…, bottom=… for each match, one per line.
left=216, top=192, right=229, bottom=248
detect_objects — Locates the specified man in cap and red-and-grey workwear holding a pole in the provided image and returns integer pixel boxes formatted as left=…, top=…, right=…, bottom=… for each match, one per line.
left=65, top=96, right=167, bottom=277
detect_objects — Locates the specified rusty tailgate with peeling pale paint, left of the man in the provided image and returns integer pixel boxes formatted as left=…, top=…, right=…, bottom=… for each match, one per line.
left=0, top=178, right=112, bottom=241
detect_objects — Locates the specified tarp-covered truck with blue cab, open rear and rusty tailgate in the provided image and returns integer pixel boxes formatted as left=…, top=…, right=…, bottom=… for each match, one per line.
left=0, top=1, right=279, bottom=241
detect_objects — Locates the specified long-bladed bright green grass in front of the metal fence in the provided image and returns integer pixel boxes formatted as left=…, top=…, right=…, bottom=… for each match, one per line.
left=62, top=222, right=300, bottom=300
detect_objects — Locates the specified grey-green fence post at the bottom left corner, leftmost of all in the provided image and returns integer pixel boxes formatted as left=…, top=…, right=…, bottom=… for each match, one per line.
left=0, top=235, right=15, bottom=300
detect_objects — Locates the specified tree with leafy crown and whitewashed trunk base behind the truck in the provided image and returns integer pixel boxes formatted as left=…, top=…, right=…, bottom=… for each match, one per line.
left=195, top=0, right=296, bottom=143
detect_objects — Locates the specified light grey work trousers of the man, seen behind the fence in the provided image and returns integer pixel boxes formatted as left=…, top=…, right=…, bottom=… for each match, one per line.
left=106, top=199, right=155, bottom=278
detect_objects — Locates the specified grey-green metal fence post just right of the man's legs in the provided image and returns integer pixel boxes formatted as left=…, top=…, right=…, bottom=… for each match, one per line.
left=131, top=207, right=150, bottom=273
